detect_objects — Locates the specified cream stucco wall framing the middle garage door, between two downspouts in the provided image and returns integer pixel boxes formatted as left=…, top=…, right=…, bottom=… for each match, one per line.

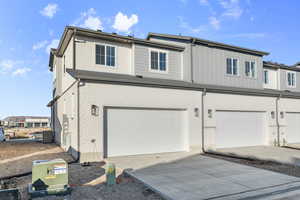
left=204, top=93, right=277, bottom=150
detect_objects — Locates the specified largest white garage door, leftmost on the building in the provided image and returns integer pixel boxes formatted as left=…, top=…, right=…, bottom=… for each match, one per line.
left=106, top=108, right=188, bottom=157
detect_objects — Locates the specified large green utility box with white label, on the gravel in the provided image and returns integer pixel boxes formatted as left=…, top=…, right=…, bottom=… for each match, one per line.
left=29, top=159, right=70, bottom=197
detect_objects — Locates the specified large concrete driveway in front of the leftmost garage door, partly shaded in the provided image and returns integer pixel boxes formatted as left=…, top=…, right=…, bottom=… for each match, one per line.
left=109, top=153, right=300, bottom=200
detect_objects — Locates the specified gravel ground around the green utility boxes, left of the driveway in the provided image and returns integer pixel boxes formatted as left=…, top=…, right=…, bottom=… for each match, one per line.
left=3, top=163, right=163, bottom=200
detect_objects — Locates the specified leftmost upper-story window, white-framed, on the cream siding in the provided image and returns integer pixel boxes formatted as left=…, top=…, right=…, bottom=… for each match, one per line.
left=96, top=44, right=116, bottom=67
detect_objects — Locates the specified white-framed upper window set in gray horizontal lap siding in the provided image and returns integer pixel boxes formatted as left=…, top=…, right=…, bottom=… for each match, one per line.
left=150, top=50, right=167, bottom=72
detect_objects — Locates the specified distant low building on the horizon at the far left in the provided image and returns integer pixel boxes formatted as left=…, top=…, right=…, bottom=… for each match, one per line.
left=3, top=116, right=50, bottom=128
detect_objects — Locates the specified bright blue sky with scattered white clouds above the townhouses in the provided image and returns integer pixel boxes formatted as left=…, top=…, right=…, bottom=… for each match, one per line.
left=0, top=0, right=300, bottom=119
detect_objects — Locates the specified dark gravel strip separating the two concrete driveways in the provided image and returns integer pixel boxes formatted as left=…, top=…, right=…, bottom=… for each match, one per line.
left=204, top=154, right=300, bottom=177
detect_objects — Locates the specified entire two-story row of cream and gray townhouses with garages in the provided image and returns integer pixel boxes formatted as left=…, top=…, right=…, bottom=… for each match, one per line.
left=48, top=27, right=300, bottom=162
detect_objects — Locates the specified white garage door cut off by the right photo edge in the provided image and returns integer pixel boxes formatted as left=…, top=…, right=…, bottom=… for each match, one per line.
left=286, top=113, right=300, bottom=144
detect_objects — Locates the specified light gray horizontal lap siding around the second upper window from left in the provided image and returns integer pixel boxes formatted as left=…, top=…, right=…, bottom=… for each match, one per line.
left=134, top=45, right=182, bottom=80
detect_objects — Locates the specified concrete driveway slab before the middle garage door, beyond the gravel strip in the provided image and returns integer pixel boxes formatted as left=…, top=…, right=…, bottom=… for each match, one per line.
left=216, top=146, right=300, bottom=166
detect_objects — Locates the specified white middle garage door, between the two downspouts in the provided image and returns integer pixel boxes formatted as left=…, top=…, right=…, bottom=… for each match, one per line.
left=216, top=111, right=266, bottom=148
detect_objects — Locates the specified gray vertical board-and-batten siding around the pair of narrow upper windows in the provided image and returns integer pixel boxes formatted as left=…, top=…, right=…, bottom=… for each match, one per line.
left=193, top=45, right=263, bottom=89
